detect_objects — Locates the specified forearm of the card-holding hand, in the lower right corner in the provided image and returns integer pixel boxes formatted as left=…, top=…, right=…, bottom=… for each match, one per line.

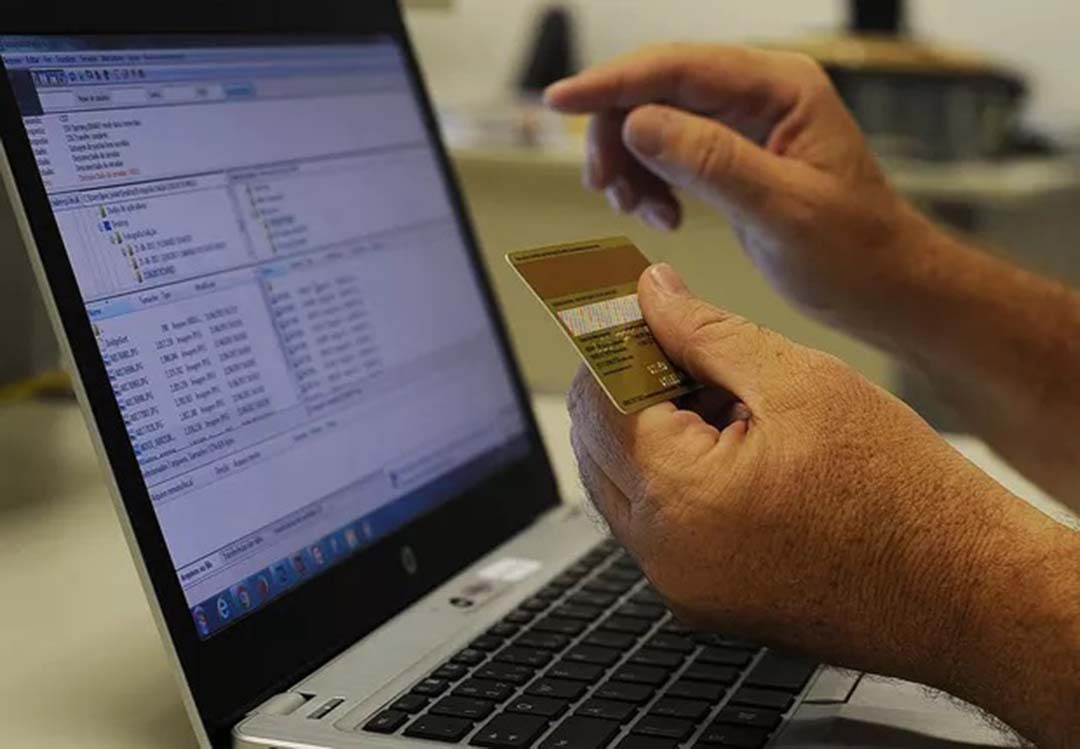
left=940, top=492, right=1080, bottom=749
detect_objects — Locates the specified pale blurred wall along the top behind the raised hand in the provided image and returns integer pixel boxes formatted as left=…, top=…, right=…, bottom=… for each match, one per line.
left=409, top=0, right=1080, bottom=136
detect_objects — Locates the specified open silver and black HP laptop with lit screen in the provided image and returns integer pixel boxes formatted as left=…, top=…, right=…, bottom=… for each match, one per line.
left=0, top=0, right=1010, bottom=749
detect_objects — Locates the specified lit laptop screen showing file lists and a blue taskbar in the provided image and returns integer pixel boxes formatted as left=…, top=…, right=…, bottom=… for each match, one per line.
left=2, top=36, right=527, bottom=639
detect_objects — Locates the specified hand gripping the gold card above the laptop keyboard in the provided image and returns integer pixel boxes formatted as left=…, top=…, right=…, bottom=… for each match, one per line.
left=569, top=265, right=1045, bottom=694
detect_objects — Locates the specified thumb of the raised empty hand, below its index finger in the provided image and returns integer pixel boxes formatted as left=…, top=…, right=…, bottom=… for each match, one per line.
left=622, top=104, right=783, bottom=210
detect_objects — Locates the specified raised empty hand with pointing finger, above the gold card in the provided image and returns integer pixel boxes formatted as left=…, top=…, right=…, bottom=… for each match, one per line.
left=545, top=44, right=932, bottom=332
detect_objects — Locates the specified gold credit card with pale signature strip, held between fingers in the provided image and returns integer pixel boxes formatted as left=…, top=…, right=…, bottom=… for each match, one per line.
left=507, top=236, right=699, bottom=413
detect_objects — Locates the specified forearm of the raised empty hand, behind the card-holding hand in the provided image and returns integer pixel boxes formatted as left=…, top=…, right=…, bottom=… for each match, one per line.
left=843, top=210, right=1080, bottom=508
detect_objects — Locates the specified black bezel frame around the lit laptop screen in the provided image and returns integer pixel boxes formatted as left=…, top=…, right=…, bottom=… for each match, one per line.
left=0, top=0, right=558, bottom=746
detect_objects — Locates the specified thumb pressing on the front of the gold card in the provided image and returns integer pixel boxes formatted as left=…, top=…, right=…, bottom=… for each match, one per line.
left=637, top=262, right=774, bottom=410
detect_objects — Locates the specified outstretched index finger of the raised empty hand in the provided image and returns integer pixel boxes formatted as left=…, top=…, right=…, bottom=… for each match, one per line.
left=544, top=44, right=800, bottom=117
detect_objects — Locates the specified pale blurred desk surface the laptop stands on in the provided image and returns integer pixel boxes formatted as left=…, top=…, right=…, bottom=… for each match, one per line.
left=0, top=397, right=1061, bottom=749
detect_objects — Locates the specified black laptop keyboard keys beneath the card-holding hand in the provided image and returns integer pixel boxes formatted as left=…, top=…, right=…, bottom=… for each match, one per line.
left=363, top=541, right=818, bottom=749
